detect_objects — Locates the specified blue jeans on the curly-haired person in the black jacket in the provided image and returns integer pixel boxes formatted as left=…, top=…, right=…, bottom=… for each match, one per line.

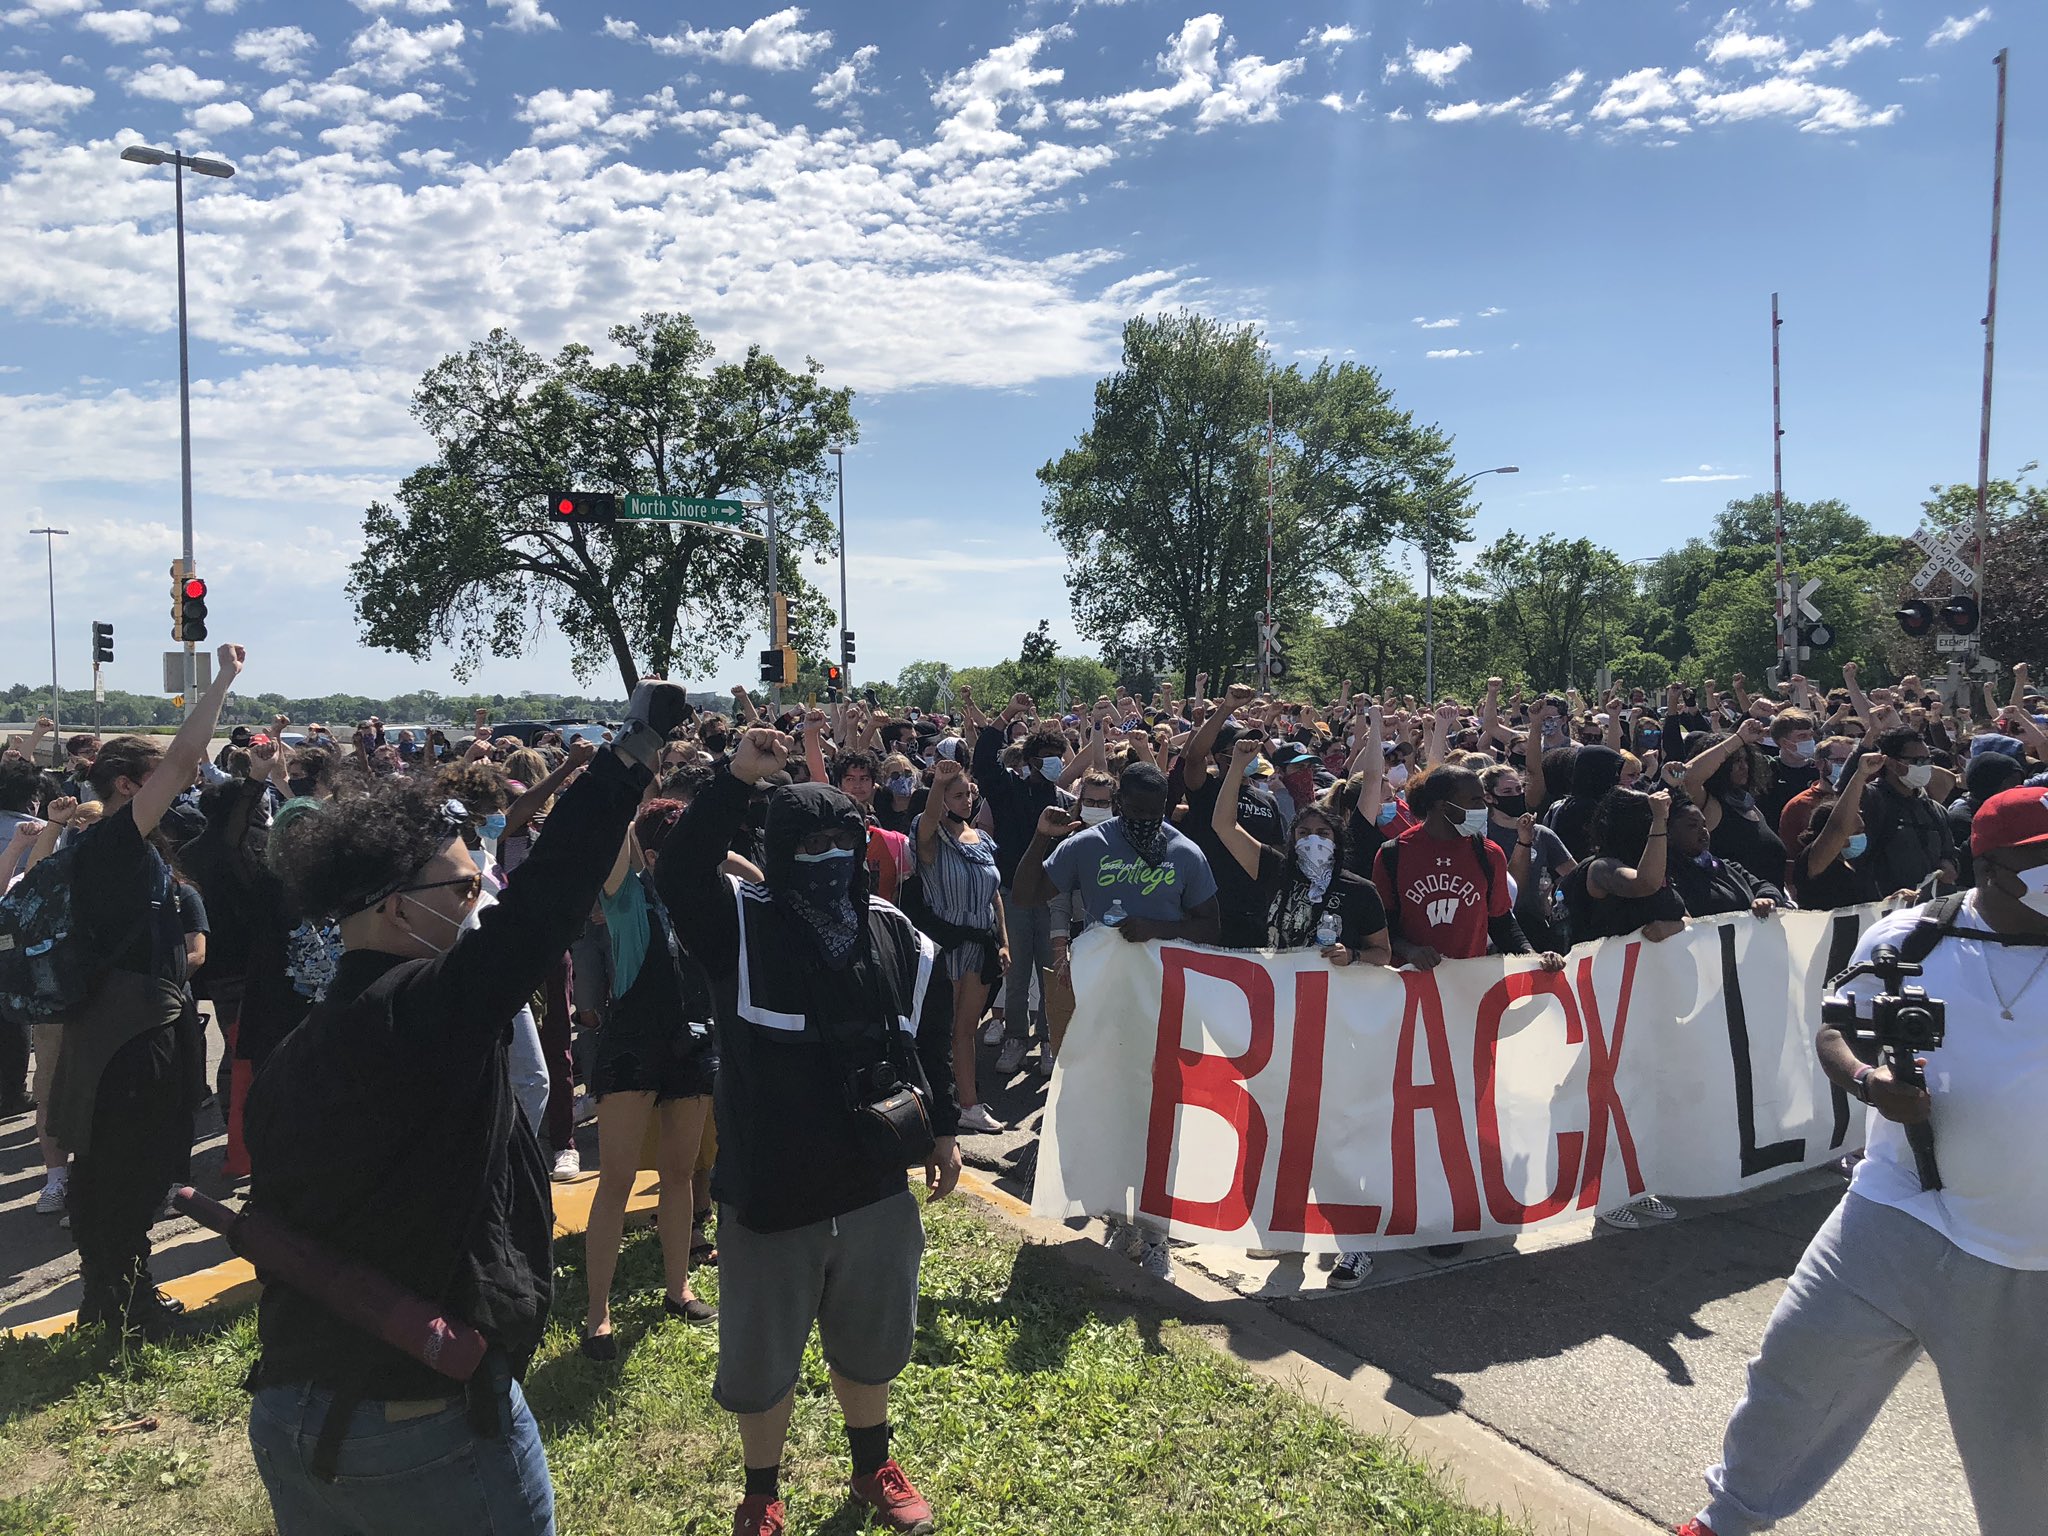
left=250, top=1356, right=555, bottom=1536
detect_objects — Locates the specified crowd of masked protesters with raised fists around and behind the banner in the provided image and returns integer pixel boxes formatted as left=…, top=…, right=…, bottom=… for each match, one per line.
left=0, top=647, right=2048, bottom=1536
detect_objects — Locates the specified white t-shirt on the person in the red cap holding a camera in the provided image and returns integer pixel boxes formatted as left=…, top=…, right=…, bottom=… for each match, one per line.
left=1845, top=895, right=2048, bottom=1270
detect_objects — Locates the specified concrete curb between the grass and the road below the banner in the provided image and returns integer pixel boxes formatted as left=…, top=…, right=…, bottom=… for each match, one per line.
left=961, top=1169, right=1663, bottom=1536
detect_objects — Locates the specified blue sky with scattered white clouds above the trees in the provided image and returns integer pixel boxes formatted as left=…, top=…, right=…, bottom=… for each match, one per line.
left=0, top=0, right=2048, bottom=694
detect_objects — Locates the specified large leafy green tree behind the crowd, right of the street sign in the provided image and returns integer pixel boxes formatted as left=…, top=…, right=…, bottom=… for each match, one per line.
left=1038, top=311, right=1470, bottom=688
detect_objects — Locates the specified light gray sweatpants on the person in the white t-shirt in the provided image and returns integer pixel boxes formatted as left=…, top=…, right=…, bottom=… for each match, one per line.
left=1700, top=1194, right=2048, bottom=1536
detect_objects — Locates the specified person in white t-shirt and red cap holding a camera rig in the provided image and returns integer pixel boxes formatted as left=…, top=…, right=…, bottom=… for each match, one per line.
left=1679, top=788, right=2048, bottom=1536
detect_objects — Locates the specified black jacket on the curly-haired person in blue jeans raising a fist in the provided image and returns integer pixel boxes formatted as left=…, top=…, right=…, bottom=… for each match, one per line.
left=244, top=752, right=647, bottom=1399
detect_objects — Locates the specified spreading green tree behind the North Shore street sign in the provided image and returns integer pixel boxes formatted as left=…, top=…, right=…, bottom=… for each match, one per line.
left=348, top=313, right=856, bottom=690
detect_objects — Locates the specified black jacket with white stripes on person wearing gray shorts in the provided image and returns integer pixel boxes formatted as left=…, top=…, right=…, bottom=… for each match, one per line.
left=655, top=770, right=961, bottom=1233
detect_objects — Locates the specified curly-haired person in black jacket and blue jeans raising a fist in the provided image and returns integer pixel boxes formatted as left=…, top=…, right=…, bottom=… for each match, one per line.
left=246, top=682, right=686, bottom=1536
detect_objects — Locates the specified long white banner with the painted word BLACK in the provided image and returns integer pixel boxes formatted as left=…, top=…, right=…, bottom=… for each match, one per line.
left=1032, top=907, right=1880, bottom=1251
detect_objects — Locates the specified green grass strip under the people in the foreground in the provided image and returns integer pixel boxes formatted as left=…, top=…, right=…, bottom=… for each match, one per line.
left=0, top=1202, right=1516, bottom=1536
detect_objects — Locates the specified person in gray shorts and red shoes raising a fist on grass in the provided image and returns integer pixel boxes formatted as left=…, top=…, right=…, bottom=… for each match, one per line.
left=653, top=727, right=961, bottom=1536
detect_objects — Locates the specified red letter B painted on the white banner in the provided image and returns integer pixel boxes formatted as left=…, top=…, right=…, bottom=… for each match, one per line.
left=1139, top=948, right=1274, bottom=1233
